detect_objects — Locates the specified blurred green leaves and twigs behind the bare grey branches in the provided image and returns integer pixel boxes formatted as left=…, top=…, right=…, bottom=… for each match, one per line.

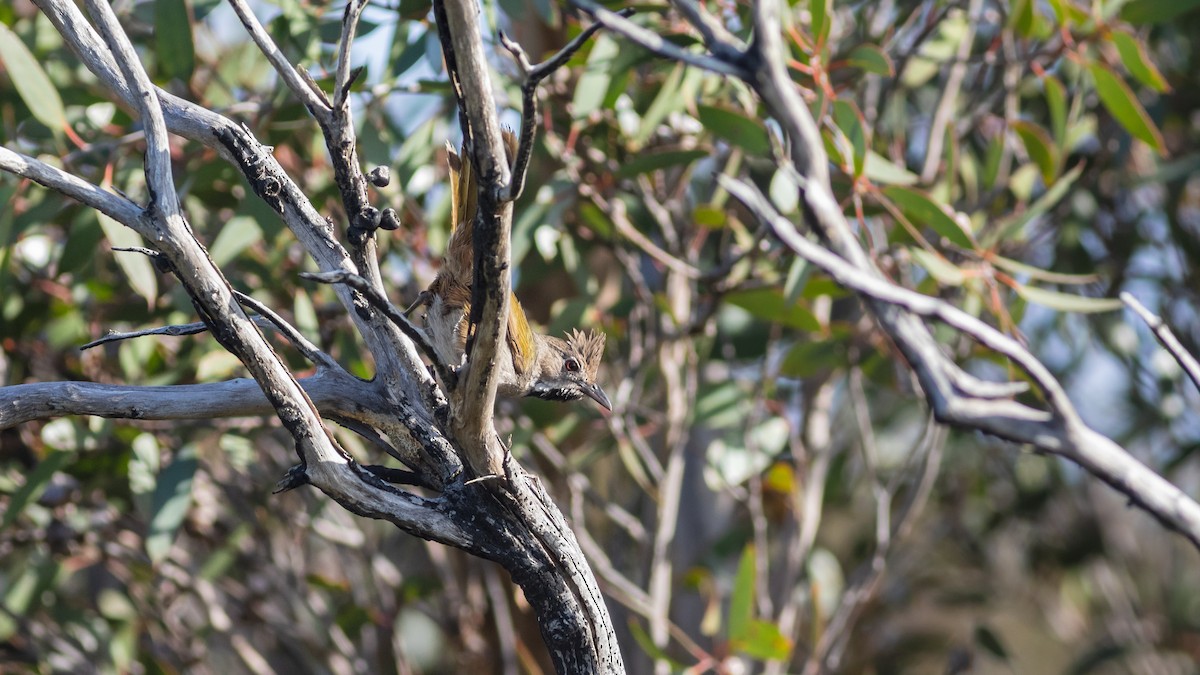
left=0, top=0, right=1200, bottom=674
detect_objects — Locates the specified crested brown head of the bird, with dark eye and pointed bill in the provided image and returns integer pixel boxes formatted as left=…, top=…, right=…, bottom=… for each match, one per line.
left=526, top=330, right=612, bottom=410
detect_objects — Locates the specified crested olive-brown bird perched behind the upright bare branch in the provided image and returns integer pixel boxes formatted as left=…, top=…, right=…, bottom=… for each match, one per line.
left=414, top=130, right=612, bottom=411
